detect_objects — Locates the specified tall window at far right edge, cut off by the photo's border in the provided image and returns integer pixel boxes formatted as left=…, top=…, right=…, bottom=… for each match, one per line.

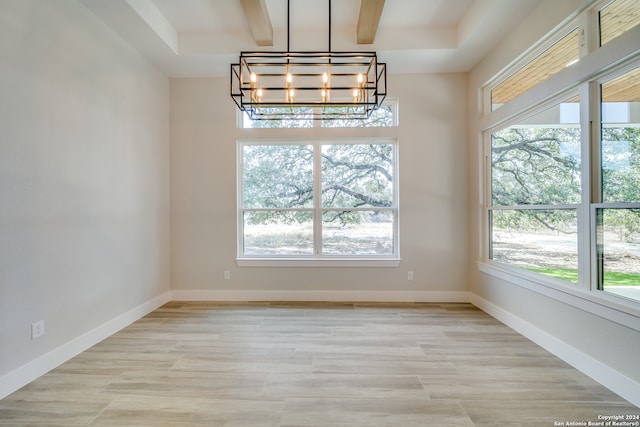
left=594, top=67, right=640, bottom=301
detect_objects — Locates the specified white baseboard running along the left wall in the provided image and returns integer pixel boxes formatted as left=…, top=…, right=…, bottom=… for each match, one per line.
left=0, top=292, right=171, bottom=399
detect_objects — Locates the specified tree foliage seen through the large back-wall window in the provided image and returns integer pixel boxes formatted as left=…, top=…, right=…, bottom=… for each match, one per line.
left=242, top=143, right=394, bottom=224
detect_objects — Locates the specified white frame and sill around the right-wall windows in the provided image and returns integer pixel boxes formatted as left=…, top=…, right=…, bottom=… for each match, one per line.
left=478, top=0, right=640, bottom=320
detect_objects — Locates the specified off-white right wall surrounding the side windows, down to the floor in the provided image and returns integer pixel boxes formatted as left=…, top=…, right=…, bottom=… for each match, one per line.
left=468, top=0, right=640, bottom=404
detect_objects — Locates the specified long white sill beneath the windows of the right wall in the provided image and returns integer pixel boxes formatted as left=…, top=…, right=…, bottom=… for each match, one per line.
left=478, top=261, right=640, bottom=331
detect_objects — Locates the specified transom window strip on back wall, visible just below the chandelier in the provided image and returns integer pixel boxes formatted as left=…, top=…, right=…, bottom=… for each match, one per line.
left=240, top=99, right=397, bottom=129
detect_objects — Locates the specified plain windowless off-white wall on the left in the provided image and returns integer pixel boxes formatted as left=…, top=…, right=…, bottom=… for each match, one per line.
left=0, top=0, right=170, bottom=397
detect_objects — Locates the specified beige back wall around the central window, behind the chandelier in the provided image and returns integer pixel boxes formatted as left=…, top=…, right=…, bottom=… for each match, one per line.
left=171, top=74, right=468, bottom=300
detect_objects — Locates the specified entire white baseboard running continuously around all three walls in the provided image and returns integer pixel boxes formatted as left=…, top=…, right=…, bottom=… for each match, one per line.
left=7, top=290, right=640, bottom=406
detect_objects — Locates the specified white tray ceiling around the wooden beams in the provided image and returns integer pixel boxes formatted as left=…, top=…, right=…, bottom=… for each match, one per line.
left=81, top=0, right=542, bottom=77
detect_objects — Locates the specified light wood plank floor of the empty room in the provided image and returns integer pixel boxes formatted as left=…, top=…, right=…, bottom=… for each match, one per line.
left=0, top=302, right=640, bottom=427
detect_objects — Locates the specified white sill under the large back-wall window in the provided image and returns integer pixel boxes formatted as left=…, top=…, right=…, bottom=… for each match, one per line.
left=236, top=258, right=401, bottom=267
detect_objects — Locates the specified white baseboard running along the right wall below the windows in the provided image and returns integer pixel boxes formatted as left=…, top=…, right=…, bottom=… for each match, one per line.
left=469, top=293, right=640, bottom=407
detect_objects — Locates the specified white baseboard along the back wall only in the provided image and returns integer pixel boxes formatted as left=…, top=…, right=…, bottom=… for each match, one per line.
left=171, top=290, right=469, bottom=302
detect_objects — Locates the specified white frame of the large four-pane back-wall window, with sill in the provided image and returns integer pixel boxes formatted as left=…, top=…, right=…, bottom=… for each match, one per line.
left=236, top=137, right=401, bottom=267
